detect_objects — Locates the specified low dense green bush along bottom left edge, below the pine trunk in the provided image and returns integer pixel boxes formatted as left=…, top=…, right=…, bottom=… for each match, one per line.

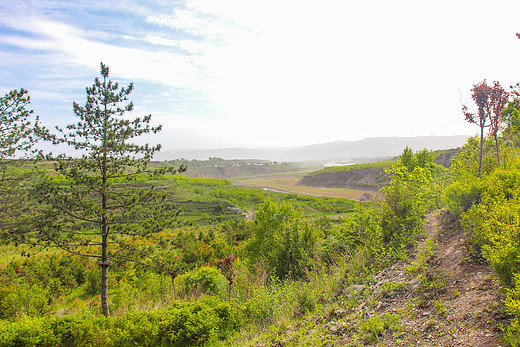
left=0, top=297, right=243, bottom=347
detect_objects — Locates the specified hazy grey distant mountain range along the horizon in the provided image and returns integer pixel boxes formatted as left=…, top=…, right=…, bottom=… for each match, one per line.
left=154, top=135, right=468, bottom=162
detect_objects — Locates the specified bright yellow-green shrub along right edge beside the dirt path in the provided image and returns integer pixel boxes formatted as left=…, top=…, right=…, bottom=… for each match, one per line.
left=451, top=157, right=520, bottom=346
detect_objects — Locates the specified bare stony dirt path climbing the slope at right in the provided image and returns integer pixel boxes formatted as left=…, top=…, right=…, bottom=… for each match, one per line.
left=364, top=210, right=507, bottom=346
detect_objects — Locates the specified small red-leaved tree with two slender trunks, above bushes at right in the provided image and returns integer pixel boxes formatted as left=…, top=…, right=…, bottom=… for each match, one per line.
left=462, top=80, right=509, bottom=177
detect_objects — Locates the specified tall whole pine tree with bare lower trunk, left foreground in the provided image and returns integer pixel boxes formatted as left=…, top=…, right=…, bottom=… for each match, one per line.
left=36, top=63, right=182, bottom=316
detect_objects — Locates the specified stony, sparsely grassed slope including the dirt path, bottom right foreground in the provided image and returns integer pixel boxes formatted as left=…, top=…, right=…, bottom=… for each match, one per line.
left=235, top=210, right=506, bottom=346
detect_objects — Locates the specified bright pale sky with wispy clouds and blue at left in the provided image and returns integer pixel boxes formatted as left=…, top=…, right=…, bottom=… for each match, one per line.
left=0, top=0, right=520, bottom=150
